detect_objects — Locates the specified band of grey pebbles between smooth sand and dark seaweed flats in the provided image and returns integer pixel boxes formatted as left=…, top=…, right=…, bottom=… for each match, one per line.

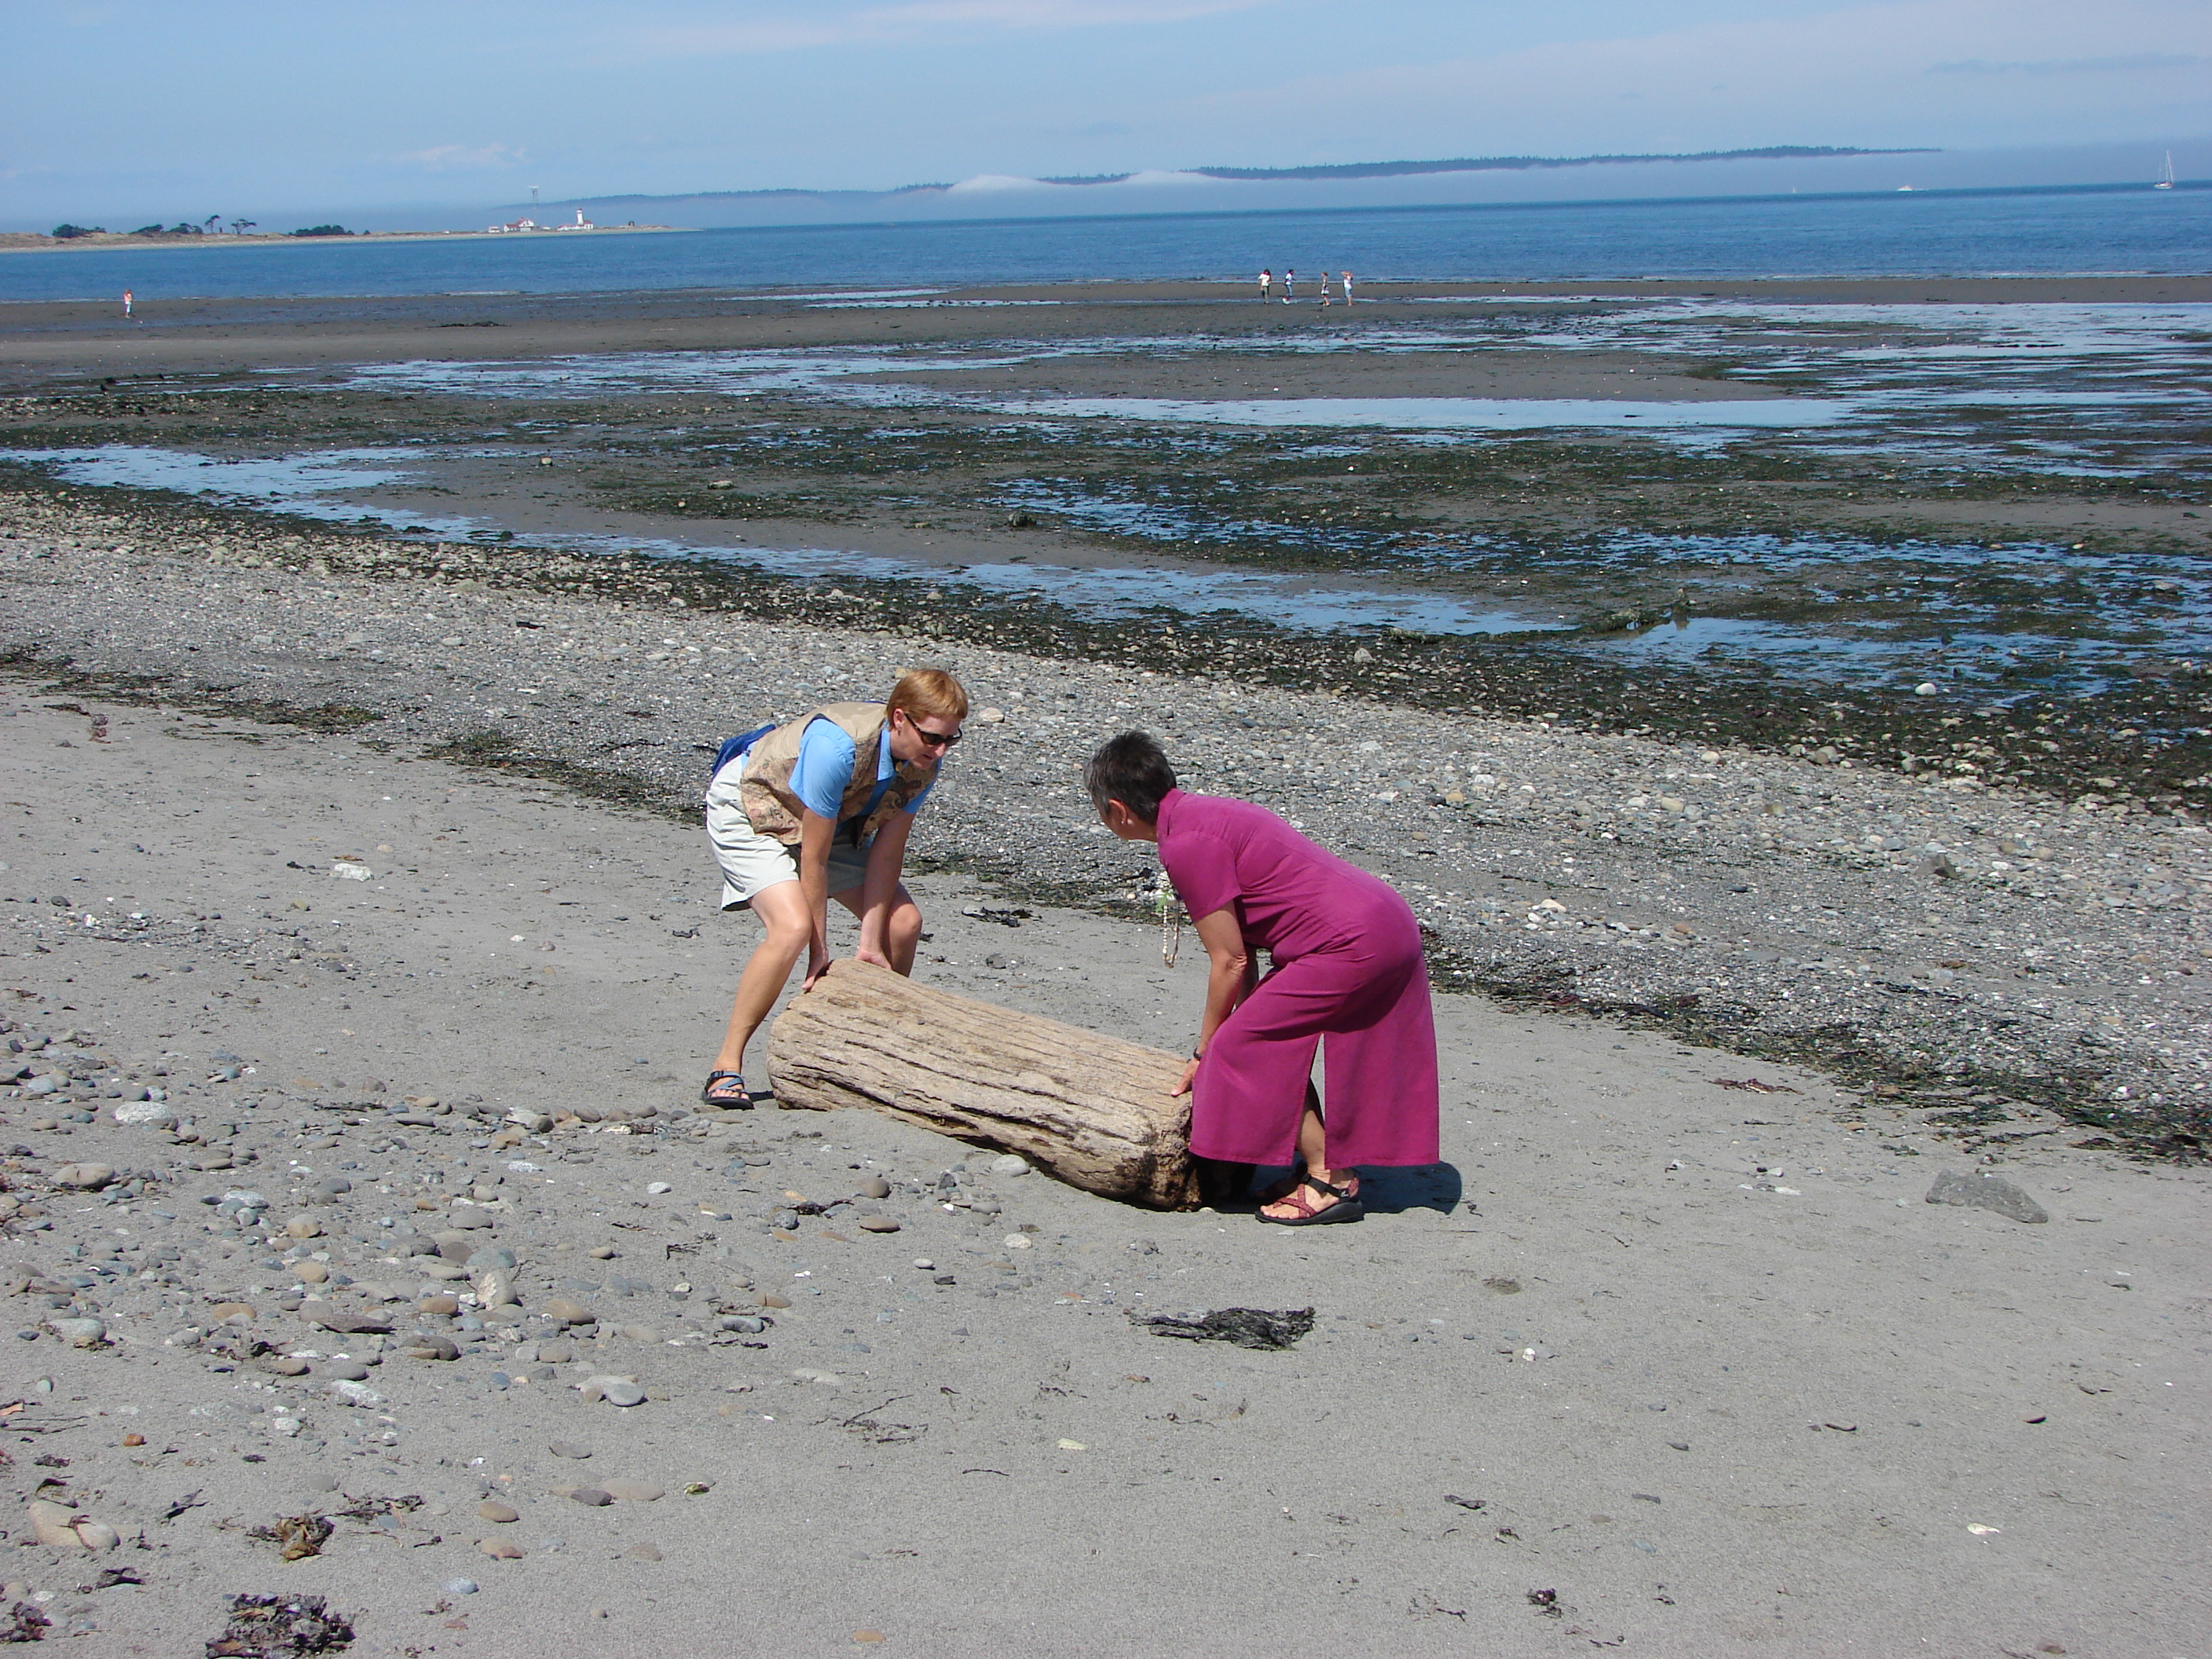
left=0, top=491, right=2212, bottom=1157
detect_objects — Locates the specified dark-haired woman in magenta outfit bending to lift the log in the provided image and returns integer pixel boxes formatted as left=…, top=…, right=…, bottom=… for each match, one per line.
left=1084, top=732, right=1437, bottom=1228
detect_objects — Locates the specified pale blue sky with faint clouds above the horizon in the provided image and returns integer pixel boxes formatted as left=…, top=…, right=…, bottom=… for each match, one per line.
left=0, top=0, right=2212, bottom=228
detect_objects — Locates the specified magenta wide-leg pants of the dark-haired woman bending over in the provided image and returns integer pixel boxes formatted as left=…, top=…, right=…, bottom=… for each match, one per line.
left=1190, top=894, right=1437, bottom=1168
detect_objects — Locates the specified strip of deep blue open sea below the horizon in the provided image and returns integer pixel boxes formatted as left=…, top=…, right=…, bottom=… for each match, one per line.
left=0, top=186, right=2212, bottom=306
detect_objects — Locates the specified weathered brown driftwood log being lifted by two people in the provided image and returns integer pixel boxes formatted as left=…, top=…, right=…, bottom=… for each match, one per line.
left=767, top=960, right=1199, bottom=1210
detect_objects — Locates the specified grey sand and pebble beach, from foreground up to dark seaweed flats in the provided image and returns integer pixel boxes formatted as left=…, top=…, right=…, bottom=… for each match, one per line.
left=0, top=491, right=2212, bottom=1657
